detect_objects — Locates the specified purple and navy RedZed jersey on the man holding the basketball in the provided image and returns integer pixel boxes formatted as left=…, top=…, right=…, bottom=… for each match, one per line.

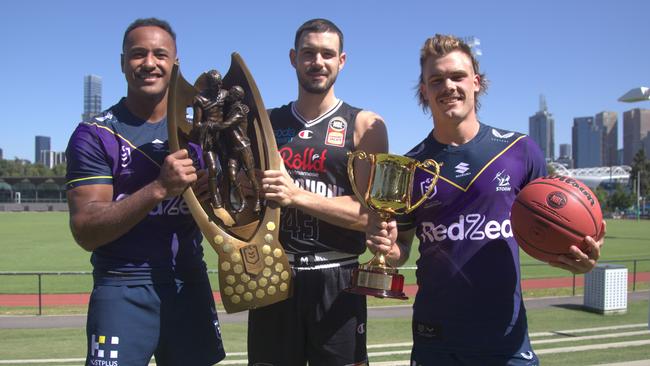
left=398, top=124, right=546, bottom=353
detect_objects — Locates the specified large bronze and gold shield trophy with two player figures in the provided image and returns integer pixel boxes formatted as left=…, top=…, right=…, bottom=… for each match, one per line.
left=167, top=53, right=291, bottom=313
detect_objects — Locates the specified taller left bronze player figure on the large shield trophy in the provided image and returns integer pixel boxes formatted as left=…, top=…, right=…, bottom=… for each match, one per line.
left=192, top=70, right=228, bottom=208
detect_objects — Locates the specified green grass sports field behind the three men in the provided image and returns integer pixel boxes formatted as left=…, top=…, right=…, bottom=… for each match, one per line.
left=0, top=212, right=650, bottom=366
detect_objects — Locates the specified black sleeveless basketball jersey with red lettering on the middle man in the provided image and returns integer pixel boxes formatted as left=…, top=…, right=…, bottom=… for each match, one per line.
left=269, top=100, right=366, bottom=255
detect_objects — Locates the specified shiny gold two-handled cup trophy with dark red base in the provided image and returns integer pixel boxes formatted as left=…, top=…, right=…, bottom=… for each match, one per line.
left=346, top=151, right=440, bottom=300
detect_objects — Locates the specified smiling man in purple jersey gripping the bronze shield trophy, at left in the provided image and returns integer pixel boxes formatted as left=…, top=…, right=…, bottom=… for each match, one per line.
left=66, top=18, right=225, bottom=366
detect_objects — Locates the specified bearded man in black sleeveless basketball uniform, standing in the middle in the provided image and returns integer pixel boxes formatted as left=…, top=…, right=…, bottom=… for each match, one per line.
left=248, top=19, right=388, bottom=366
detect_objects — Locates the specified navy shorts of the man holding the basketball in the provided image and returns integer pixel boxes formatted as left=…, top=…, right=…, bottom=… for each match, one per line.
left=411, top=335, right=539, bottom=366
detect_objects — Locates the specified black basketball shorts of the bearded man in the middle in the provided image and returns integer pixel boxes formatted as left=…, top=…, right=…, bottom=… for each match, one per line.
left=248, top=264, right=368, bottom=366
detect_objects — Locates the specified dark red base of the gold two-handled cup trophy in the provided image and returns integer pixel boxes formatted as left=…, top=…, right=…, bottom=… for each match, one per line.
left=345, top=268, right=408, bottom=300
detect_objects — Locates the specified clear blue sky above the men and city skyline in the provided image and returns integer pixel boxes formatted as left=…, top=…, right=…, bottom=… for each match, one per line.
left=0, top=0, right=650, bottom=161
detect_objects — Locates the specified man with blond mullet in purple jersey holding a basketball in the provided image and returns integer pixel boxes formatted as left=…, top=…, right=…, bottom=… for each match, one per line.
left=366, top=35, right=604, bottom=366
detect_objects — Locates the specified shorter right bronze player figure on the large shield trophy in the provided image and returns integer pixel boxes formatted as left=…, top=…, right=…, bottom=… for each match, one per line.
left=221, top=85, right=261, bottom=213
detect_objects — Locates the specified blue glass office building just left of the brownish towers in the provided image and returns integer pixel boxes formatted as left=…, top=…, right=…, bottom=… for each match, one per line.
left=571, top=117, right=603, bottom=168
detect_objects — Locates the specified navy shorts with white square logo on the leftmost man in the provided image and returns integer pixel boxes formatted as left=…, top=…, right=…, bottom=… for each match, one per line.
left=86, top=282, right=225, bottom=366
